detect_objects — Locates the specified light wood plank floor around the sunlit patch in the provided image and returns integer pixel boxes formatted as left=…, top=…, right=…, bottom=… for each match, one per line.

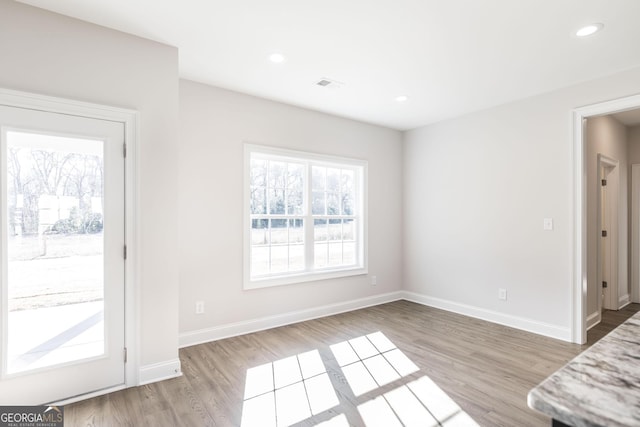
left=65, top=301, right=640, bottom=427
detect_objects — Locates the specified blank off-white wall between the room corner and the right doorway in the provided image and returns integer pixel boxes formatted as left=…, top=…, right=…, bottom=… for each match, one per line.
left=404, top=68, right=640, bottom=340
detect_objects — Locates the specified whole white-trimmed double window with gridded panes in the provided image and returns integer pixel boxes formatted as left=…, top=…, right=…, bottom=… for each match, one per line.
left=244, top=144, right=367, bottom=289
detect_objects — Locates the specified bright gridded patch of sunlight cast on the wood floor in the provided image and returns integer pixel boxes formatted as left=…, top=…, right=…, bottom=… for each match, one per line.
left=242, top=331, right=478, bottom=427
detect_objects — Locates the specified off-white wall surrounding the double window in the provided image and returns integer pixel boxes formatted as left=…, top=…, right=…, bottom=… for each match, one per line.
left=179, top=81, right=402, bottom=345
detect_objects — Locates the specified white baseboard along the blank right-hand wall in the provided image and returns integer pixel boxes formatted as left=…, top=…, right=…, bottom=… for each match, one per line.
left=401, top=291, right=571, bottom=342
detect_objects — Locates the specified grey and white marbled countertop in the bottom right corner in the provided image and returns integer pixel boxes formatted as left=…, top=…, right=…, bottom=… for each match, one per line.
left=528, top=313, right=640, bottom=427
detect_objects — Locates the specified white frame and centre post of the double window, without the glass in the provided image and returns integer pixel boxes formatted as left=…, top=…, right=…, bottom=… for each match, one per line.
left=243, top=143, right=368, bottom=289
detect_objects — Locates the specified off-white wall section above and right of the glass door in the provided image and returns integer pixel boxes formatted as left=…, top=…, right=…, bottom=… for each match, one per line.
left=0, top=0, right=178, bottom=379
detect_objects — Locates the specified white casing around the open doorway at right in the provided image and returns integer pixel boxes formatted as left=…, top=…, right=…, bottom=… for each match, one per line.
left=570, top=95, right=640, bottom=344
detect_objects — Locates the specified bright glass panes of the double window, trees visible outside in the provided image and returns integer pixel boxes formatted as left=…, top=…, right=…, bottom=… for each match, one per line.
left=249, top=149, right=361, bottom=278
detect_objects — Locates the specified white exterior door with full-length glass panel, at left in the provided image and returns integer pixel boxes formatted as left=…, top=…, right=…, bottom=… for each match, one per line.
left=0, top=106, right=125, bottom=405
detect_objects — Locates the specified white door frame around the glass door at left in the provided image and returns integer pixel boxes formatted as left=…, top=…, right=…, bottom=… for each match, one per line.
left=0, top=88, right=140, bottom=405
